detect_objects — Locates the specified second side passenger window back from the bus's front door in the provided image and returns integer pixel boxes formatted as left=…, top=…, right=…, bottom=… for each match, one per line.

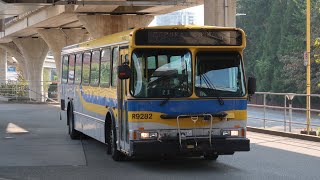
left=100, top=49, right=111, bottom=87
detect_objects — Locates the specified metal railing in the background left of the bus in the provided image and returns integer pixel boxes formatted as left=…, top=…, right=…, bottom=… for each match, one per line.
left=0, top=81, right=58, bottom=103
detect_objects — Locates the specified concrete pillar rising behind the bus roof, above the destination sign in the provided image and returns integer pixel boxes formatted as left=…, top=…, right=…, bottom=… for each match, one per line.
left=204, top=0, right=237, bottom=27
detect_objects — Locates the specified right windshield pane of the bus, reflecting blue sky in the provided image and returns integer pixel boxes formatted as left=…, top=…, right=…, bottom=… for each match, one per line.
left=195, top=52, right=246, bottom=98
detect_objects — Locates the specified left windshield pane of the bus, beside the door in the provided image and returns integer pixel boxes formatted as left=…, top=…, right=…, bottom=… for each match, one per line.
left=130, top=49, right=192, bottom=98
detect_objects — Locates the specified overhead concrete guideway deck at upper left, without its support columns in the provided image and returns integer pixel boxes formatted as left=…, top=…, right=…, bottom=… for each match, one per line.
left=0, top=0, right=203, bottom=42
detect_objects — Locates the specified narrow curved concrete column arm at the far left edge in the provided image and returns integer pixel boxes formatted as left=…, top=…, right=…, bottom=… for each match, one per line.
left=0, top=42, right=28, bottom=80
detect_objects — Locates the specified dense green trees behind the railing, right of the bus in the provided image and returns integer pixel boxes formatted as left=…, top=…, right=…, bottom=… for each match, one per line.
left=237, top=0, right=320, bottom=93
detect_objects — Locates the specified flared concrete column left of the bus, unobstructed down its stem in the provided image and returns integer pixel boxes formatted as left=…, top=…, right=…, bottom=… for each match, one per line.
left=13, top=38, right=49, bottom=101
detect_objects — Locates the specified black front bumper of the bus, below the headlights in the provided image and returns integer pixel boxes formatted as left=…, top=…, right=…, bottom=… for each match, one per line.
left=130, top=138, right=250, bottom=156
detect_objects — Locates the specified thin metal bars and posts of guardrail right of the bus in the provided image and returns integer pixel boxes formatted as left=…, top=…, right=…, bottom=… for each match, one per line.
left=248, top=92, right=320, bottom=135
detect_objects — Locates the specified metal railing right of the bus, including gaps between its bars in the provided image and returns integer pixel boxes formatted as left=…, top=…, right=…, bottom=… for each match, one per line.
left=248, top=92, right=320, bottom=135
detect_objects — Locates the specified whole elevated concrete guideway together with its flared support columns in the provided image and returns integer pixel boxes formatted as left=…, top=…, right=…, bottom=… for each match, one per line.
left=0, top=0, right=236, bottom=99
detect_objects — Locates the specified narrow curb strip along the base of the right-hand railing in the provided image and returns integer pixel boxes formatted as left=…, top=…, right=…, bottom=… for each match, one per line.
left=247, top=126, right=320, bottom=142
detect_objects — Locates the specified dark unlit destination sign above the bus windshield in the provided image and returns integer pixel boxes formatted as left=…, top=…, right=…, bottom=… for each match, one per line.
left=135, top=29, right=242, bottom=46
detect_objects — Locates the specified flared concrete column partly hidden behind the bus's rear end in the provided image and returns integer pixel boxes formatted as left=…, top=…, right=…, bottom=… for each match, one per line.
left=37, top=29, right=88, bottom=80
